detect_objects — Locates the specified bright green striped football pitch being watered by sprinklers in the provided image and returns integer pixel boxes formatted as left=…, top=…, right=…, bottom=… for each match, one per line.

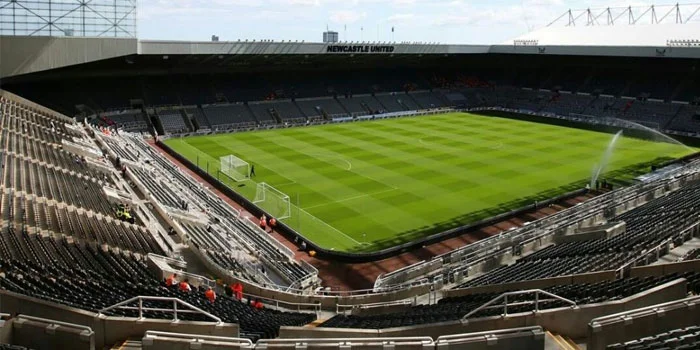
left=166, top=113, right=692, bottom=252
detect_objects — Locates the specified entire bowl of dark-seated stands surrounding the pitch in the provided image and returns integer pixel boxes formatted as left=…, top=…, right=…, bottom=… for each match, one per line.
left=5, top=24, right=700, bottom=350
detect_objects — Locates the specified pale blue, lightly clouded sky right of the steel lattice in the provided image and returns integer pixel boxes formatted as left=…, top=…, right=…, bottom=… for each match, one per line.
left=138, top=0, right=680, bottom=44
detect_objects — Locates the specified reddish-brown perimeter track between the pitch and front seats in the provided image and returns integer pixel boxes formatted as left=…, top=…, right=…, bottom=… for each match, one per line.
left=148, top=140, right=595, bottom=290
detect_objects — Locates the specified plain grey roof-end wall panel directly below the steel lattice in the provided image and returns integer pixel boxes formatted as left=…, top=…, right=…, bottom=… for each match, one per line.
left=0, top=36, right=138, bottom=78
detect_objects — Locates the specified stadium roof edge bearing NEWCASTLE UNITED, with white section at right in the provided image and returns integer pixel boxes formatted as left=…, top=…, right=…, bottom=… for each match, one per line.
left=0, top=28, right=700, bottom=78
